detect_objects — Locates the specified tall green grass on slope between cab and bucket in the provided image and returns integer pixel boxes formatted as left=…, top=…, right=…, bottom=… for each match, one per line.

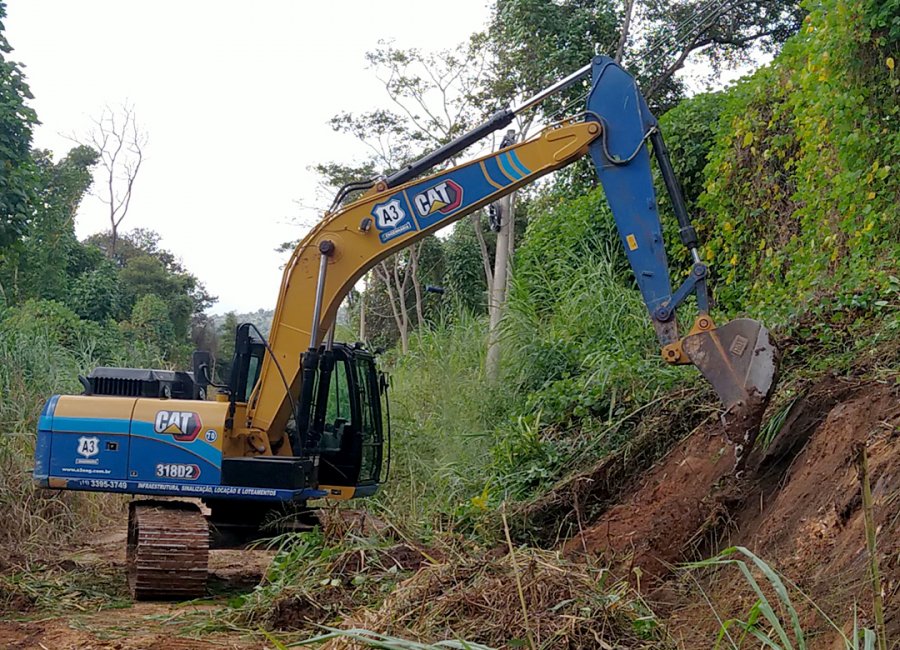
left=381, top=214, right=697, bottom=528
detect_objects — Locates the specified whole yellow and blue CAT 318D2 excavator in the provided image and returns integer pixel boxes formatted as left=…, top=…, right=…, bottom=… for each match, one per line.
left=34, top=56, right=777, bottom=599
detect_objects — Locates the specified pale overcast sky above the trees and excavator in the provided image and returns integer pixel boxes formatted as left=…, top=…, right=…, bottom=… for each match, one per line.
left=6, top=0, right=488, bottom=313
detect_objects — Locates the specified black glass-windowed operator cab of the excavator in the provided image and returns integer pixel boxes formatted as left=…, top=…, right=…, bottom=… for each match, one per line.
left=228, top=324, right=390, bottom=499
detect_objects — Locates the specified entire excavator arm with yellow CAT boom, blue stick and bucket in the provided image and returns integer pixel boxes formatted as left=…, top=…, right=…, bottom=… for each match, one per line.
left=278, top=56, right=776, bottom=457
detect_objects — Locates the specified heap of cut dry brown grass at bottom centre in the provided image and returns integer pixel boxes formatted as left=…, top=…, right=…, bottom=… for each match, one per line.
left=323, top=548, right=674, bottom=650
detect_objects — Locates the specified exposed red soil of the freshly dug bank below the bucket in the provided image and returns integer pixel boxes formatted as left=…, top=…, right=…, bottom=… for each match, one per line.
left=564, top=379, right=900, bottom=648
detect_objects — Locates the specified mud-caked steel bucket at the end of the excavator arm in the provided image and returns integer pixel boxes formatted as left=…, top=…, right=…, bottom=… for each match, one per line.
left=682, top=318, right=778, bottom=454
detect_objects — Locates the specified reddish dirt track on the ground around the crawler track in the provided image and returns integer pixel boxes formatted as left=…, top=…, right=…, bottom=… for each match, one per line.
left=0, top=527, right=272, bottom=650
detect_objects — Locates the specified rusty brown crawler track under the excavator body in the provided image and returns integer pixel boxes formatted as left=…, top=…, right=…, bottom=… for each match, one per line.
left=127, top=501, right=209, bottom=600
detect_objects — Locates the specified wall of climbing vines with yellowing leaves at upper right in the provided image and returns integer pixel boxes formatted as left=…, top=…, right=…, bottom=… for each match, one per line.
left=698, top=0, right=900, bottom=325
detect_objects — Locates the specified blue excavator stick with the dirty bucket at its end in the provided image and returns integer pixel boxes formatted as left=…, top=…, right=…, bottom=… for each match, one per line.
left=587, top=56, right=777, bottom=459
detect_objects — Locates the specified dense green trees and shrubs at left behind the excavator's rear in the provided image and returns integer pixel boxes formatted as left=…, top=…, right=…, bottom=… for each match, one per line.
left=0, top=3, right=215, bottom=548
